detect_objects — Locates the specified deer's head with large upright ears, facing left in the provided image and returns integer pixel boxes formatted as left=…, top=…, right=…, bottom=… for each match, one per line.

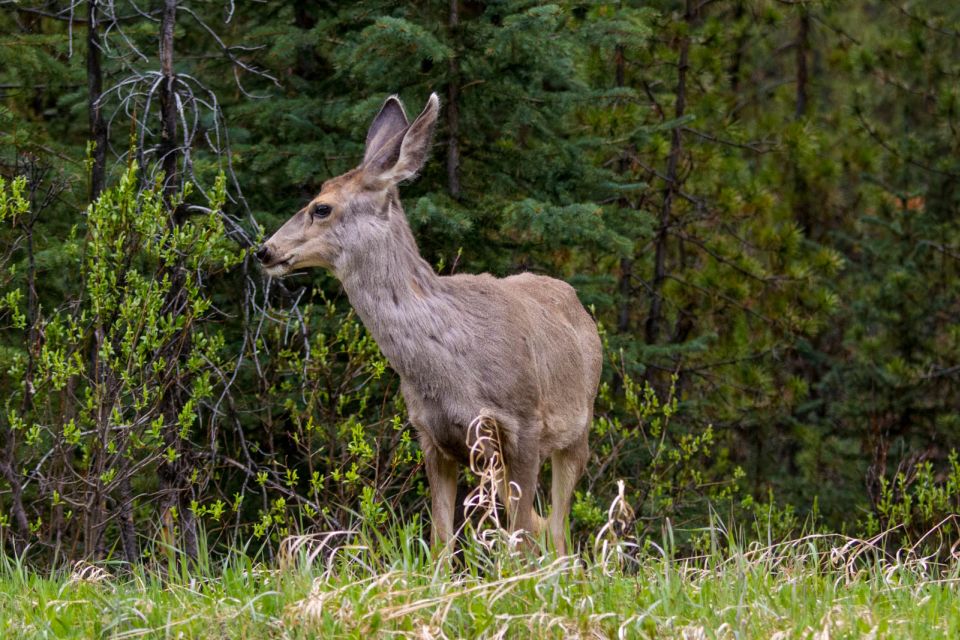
left=256, top=93, right=440, bottom=276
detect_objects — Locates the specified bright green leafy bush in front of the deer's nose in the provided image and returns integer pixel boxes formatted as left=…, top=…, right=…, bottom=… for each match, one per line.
left=0, top=168, right=243, bottom=560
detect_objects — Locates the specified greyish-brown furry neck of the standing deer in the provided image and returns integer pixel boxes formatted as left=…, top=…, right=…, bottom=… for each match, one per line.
left=340, top=200, right=455, bottom=382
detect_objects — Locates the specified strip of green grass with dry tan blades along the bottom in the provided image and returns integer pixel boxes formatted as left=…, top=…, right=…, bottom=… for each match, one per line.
left=0, top=526, right=960, bottom=639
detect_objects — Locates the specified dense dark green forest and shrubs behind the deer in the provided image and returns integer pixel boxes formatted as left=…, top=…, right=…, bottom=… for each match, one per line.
left=0, top=0, right=960, bottom=561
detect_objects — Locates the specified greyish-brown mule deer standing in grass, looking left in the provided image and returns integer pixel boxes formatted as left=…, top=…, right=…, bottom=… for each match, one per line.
left=256, top=94, right=601, bottom=554
